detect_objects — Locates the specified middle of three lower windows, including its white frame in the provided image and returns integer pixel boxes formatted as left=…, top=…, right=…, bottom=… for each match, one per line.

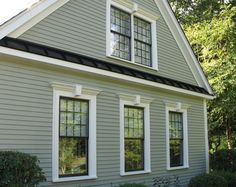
left=119, top=94, right=151, bottom=176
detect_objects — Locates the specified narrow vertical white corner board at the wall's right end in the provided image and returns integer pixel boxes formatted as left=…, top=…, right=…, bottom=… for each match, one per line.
left=203, top=99, right=210, bottom=173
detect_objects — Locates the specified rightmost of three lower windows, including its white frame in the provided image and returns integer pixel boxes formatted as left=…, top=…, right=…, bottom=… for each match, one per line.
left=166, top=103, right=189, bottom=170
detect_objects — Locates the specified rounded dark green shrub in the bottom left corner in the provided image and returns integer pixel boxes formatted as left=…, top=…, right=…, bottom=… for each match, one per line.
left=0, top=151, right=46, bottom=187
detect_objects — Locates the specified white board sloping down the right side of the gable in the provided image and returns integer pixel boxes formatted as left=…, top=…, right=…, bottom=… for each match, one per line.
left=154, top=0, right=213, bottom=94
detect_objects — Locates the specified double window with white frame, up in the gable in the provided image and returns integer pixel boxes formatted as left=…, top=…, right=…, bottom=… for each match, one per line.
left=106, top=0, right=158, bottom=70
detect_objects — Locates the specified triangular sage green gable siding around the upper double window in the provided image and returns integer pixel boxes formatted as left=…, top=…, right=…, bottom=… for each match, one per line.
left=19, top=0, right=197, bottom=85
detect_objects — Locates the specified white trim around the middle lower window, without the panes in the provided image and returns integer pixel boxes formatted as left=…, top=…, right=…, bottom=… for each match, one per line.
left=118, top=94, right=152, bottom=176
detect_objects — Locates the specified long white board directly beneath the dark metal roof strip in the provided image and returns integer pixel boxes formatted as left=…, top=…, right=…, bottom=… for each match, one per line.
left=0, top=47, right=215, bottom=99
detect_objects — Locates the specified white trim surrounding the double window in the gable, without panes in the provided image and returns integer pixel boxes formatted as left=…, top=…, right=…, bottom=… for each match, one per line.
left=106, top=0, right=158, bottom=70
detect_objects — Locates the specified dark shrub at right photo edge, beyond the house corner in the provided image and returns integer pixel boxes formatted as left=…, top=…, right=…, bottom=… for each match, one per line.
left=210, top=149, right=236, bottom=172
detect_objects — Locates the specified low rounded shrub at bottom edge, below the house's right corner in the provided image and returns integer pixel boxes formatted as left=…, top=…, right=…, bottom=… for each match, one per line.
left=189, top=173, right=227, bottom=187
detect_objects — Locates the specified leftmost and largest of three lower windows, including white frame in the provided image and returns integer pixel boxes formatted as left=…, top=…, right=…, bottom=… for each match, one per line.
left=52, top=83, right=100, bottom=182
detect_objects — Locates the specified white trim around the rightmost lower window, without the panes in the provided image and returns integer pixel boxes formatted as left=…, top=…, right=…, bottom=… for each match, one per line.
left=166, top=102, right=189, bottom=170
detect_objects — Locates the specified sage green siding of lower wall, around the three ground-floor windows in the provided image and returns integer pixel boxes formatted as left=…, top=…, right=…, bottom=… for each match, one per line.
left=0, top=58, right=205, bottom=187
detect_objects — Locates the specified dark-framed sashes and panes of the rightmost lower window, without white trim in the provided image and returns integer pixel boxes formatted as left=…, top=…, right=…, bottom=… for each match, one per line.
left=169, top=111, right=184, bottom=167
